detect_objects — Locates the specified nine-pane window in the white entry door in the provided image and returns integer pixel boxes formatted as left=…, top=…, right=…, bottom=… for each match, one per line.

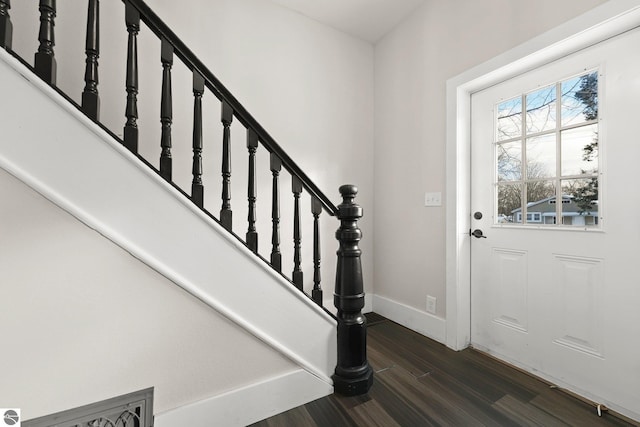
left=494, top=70, right=600, bottom=228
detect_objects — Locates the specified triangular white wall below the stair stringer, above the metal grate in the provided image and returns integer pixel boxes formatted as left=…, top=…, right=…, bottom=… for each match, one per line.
left=0, top=169, right=297, bottom=419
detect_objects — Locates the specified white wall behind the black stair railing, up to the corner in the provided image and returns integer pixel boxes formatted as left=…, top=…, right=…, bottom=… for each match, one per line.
left=11, top=0, right=373, bottom=305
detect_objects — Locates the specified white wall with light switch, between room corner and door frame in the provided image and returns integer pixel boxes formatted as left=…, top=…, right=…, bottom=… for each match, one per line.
left=374, top=0, right=603, bottom=327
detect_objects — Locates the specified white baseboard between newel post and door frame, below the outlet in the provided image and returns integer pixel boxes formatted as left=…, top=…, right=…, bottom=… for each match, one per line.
left=373, top=295, right=446, bottom=344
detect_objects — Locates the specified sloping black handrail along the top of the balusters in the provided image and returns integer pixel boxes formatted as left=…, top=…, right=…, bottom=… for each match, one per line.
left=123, top=0, right=338, bottom=216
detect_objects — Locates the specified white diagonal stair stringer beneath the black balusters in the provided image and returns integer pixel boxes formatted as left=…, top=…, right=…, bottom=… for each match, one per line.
left=0, top=49, right=337, bottom=394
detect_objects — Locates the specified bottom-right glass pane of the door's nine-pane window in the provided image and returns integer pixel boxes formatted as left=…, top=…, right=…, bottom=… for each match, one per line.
left=562, top=178, right=598, bottom=227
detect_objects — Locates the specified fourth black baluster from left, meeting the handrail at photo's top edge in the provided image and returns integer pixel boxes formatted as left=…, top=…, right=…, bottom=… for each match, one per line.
left=124, top=1, right=140, bottom=153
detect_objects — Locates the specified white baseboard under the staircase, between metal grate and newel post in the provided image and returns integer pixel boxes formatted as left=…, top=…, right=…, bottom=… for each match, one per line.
left=154, top=369, right=333, bottom=427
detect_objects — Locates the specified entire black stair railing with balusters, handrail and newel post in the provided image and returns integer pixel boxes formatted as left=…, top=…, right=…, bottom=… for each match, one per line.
left=0, top=0, right=373, bottom=395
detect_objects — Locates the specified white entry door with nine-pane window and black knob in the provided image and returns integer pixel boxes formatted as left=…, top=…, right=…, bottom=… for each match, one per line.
left=471, top=25, right=640, bottom=420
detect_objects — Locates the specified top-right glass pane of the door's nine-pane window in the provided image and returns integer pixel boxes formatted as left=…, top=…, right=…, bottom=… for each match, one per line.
left=561, top=71, right=598, bottom=126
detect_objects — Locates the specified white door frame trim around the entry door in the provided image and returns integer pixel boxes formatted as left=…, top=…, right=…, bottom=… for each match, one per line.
left=446, top=0, right=640, bottom=350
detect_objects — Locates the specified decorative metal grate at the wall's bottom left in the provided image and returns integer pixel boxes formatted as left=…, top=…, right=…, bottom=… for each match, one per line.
left=22, top=387, right=153, bottom=427
